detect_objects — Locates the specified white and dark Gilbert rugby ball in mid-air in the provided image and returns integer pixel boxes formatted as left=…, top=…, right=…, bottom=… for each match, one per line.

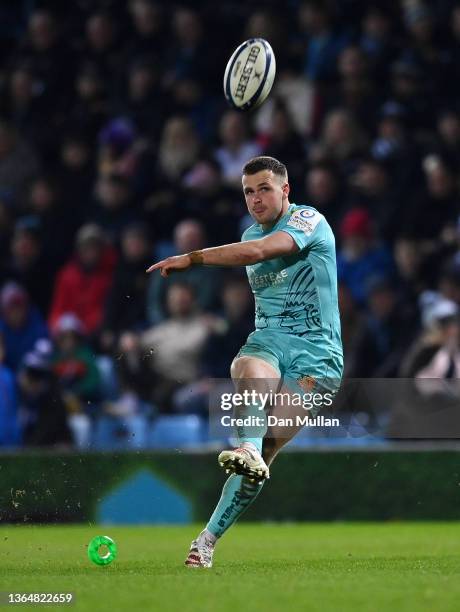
left=224, top=38, right=276, bottom=110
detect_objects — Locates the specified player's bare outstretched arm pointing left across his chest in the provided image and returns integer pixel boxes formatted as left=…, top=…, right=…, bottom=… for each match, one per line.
left=147, top=232, right=299, bottom=276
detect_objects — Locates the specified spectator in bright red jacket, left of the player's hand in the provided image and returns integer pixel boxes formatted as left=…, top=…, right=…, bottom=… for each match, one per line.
left=49, top=224, right=116, bottom=335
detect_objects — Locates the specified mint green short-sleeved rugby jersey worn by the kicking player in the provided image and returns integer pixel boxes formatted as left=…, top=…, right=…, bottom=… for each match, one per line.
left=241, top=204, right=342, bottom=356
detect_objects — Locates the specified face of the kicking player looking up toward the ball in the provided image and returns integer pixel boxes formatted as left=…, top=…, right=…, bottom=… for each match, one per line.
left=243, top=170, right=289, bottom=225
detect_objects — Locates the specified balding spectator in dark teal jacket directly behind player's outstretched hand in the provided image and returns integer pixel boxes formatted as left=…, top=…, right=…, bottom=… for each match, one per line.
left=147, top=219, right=220, bottom=325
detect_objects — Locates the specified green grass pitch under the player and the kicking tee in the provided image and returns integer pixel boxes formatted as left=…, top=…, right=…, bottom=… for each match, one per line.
left=0, top=523, right=460, bottom=612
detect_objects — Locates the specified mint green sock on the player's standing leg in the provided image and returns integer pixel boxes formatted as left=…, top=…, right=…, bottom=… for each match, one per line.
left=206, top=470, right=264, bottom=538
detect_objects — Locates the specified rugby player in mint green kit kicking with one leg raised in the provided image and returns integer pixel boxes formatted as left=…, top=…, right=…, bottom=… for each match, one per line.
left=147, top=156, right=343, bottom=567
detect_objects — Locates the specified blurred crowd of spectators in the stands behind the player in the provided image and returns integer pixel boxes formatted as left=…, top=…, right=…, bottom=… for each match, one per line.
left=0, top=0, right=460, bottom=447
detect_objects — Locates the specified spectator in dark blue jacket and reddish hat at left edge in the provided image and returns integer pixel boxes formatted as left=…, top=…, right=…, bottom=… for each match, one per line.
left=0, top=282, right=48, bottom=372
